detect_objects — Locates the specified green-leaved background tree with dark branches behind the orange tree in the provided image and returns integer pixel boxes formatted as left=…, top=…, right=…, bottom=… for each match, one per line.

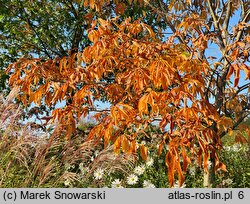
left=0, top=0, right=166, bottom=90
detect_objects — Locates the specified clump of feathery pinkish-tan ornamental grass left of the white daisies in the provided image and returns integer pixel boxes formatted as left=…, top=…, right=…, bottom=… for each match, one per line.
left=0, top=93, right=137, bottom=187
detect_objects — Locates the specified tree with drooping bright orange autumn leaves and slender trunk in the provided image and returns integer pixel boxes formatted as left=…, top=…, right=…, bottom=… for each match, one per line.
left=4, top=0, right=250, bottom=187
